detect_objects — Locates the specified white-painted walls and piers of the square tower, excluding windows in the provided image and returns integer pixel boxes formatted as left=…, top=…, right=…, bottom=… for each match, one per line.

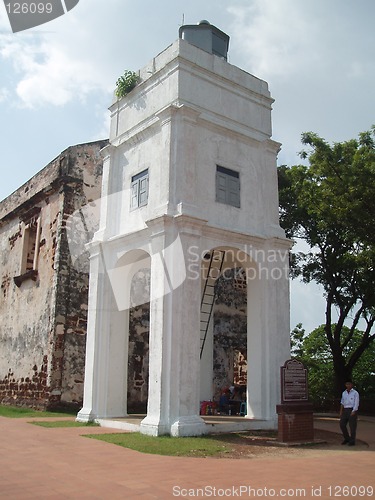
left=78, top=35, right=290, bottom=436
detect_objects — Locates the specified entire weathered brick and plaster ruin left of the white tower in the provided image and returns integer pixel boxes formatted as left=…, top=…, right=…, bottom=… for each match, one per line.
left=0, top=141, right=106, bottom=407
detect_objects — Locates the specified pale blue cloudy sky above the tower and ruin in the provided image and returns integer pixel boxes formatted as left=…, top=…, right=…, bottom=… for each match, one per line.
left=0, top=0, right=375, bottom=332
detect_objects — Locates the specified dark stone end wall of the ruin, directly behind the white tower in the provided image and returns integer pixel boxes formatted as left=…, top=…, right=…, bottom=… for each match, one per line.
left=50, top=141, right=106, bottom=406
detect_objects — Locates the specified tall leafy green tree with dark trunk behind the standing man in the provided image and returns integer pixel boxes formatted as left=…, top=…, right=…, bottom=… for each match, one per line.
left=278, top=127, right=375, bottom=396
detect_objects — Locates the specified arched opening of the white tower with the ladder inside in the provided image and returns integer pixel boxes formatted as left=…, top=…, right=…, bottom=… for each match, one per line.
left=200, top=247, right=256, bottom=414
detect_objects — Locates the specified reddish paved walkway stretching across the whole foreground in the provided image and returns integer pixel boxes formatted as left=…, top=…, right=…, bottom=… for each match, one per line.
left=0, top=417, right=375, bottom=500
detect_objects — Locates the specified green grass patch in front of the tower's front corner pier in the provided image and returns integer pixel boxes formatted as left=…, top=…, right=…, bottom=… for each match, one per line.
left=85, top=432, right=232, bottom=457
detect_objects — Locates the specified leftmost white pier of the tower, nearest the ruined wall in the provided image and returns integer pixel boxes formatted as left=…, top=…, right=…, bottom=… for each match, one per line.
left=77, top=243, right=130, bottom=422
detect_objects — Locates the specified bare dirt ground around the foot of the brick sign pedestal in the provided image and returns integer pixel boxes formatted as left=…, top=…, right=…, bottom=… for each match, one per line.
left=212, top=430, right=368, bottom=459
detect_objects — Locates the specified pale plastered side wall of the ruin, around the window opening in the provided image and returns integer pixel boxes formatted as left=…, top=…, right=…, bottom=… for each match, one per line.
left=0, top=190, right=61, bottom=407
